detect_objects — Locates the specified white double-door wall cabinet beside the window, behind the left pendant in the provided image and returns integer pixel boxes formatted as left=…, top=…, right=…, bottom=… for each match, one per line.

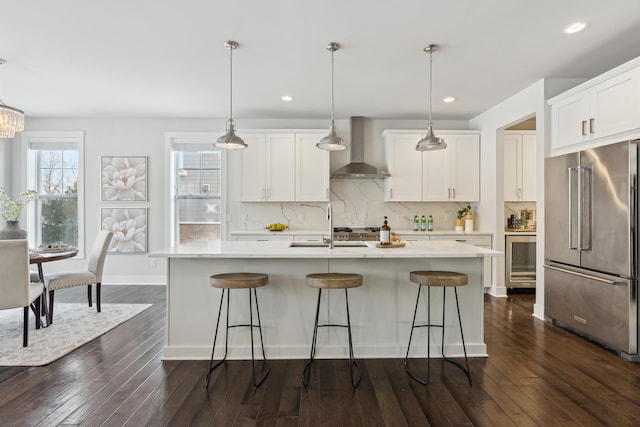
left=240, top=134, right=295, bottom=202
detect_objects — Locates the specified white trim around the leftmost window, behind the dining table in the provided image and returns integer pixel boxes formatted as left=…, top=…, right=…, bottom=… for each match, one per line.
left=21, top=131, right=86, bottom=258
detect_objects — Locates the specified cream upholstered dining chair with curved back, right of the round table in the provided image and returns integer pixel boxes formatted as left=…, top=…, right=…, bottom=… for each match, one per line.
left=44, top=230, right=113, bottom=324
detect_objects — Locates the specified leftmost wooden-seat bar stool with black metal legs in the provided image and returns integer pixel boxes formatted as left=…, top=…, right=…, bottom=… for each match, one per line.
left=204, top=273, right=270, bottom=389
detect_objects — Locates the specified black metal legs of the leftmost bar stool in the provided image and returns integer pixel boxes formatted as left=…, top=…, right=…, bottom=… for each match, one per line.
left=204, top=288, right=271, bottom=389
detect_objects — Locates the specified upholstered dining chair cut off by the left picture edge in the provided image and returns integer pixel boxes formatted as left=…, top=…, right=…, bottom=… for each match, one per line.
left=0, top=239, right=42, bottom=347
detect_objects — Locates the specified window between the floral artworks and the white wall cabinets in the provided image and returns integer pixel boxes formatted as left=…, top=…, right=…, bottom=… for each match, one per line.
left=167, top=134, right=224, bottom=245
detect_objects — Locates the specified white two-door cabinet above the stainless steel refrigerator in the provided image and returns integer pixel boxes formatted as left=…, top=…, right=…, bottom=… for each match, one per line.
left=549, top=62, right=640, bottom=150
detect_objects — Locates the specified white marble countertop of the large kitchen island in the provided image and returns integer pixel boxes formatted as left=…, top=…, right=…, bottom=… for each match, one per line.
left=148, top=241, right=504, bottom=259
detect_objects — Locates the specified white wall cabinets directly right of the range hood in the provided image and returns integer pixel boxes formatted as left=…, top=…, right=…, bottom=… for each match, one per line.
left=383, top=131, right=480, bottom=202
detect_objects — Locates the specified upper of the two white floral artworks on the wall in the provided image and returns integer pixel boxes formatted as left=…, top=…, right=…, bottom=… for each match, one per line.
left=101, top=156, right=147, bottom=202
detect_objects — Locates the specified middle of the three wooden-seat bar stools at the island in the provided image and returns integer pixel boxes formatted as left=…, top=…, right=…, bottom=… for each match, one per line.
left=302, top=273, right=362, bottom=388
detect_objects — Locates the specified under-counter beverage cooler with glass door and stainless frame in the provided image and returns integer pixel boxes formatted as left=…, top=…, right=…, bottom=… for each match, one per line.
left=505, top=234, right=536, bottom=288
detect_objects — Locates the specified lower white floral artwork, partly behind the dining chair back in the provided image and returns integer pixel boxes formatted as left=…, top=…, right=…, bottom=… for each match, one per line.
left=100, top=208, right=147, bottom=254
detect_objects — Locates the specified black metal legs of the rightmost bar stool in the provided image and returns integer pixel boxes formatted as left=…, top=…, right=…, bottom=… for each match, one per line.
left=404, top=285, right=471, bottom=385
